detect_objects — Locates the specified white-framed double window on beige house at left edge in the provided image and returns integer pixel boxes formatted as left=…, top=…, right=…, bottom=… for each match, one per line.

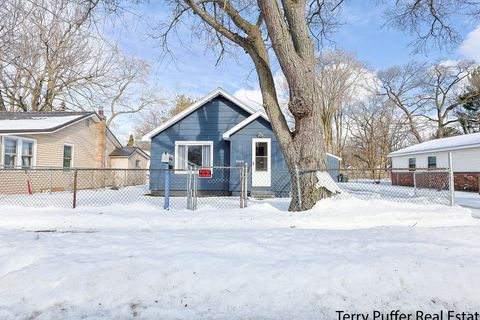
left=0, top=137, right=35, bottom=168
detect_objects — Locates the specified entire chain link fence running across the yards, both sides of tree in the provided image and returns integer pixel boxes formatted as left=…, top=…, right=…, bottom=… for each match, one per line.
left=0, top=166, right=453, bottom=210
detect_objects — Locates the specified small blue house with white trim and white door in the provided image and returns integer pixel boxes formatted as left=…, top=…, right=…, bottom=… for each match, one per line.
left=143, top=88, right=341, bottom=196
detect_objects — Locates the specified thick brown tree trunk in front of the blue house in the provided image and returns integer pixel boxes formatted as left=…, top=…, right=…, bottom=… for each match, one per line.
left=258, top=0, right=330, bottom=211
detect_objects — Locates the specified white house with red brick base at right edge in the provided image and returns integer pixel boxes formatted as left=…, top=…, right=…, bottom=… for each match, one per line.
left=389, top=133, right=480, bottom=191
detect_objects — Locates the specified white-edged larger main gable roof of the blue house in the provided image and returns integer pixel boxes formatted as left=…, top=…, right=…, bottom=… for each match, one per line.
left=142, top=88, right=255, bottom=141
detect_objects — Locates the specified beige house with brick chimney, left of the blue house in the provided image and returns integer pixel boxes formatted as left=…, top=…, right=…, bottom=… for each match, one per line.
left=0, top=112, right=149, bottom=193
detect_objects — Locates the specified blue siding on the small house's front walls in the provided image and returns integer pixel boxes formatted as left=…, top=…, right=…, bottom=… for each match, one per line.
left=150, top=97, right=340, bottom=194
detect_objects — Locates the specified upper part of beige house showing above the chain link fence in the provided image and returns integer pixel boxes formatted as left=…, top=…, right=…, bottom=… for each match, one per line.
left=0, top=112, right=149, bottom=168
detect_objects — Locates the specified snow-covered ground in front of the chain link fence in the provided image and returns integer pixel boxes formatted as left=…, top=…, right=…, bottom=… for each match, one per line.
left=0, top=198, right=480, bottom=319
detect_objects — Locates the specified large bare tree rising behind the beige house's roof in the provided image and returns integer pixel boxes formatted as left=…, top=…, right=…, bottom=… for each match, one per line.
left=0, top=0, right=110, bottom=111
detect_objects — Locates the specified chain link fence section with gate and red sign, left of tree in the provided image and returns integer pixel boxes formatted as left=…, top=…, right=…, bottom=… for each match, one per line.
left=0, top=167, right=246, bottom=210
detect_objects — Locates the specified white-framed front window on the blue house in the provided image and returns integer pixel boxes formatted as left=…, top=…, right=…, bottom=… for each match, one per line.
left=175, top=141, right=213, bottom=170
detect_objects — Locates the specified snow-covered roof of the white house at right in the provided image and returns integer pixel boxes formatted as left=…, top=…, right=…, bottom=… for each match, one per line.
left=388, top=133, right=480, bottom=157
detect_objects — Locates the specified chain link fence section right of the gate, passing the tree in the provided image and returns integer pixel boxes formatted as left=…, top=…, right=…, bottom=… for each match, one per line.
left=248, top=168, right=454, bottom=206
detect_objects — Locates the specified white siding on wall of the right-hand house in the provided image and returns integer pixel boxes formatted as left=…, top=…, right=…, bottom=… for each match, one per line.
left=392, top=148, right=480, bottom=172
